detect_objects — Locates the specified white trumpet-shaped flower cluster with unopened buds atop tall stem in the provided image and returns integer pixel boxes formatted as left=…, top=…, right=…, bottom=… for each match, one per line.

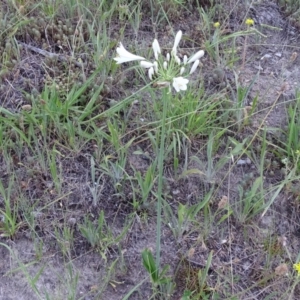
left=114, top=30, right=204, bottom=92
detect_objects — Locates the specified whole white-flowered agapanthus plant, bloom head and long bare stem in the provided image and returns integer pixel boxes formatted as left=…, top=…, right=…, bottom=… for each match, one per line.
left=114, top=31, right=204, bottom=270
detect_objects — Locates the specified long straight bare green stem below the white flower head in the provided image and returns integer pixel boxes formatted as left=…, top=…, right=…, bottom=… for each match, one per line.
left=156, top=88, right=169, bottom=271
